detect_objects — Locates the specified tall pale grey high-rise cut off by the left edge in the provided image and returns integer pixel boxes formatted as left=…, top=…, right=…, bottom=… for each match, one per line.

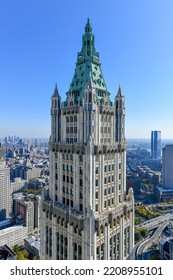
left=0, top=160, right=11, bottom=221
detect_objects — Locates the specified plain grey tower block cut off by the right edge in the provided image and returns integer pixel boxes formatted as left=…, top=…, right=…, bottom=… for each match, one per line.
left=162, top=145, right=173, bottom=189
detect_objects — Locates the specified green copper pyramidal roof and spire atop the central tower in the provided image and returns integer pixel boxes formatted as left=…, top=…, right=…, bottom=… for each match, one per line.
left=67, top=18, right=109, bottom=106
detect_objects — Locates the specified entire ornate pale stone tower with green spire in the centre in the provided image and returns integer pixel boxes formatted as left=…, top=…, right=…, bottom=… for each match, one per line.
left=41, top=19, right=134, bottom=260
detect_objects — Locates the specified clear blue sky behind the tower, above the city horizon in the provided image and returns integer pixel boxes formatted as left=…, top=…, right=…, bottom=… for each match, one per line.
left=0, top=0, right=173, bottom=139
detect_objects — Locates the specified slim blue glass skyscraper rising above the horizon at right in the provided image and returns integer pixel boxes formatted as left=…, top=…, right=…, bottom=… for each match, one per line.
left=151, top=130, right=161, bottom=159
